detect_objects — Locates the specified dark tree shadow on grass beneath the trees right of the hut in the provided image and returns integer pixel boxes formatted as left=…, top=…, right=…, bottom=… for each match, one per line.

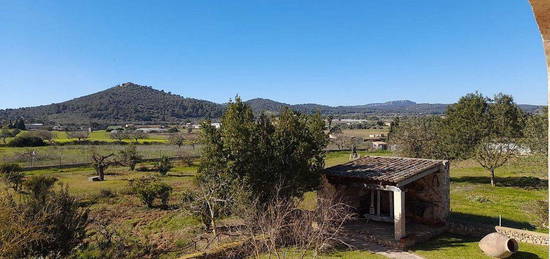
left=451, top=176, right=548, bottom=189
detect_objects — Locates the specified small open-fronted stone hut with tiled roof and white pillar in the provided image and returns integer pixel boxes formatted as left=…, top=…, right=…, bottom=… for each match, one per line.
left=324, top=156, right=450, bottom=243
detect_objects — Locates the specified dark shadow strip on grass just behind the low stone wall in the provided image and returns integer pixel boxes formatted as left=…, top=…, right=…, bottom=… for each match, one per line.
left=449, top=212, right=536, bottom=232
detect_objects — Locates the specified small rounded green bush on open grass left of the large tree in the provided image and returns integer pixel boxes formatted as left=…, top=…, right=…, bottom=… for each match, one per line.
left=130, top=177, right=172, bottom=208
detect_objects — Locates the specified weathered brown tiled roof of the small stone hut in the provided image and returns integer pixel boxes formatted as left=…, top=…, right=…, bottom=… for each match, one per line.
left=325, top=156, right=445, bottom=185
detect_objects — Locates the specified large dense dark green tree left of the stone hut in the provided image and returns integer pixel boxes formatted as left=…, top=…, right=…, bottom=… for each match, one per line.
left=197, top=97, right=327, bottom=210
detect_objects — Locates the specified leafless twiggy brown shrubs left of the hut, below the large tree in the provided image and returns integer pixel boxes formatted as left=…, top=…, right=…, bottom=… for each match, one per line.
left=238, top=190, right=355, bottom=258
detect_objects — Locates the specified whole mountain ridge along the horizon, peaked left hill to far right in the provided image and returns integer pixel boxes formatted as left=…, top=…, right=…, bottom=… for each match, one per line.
left=0, top=82, right=540, bottom=125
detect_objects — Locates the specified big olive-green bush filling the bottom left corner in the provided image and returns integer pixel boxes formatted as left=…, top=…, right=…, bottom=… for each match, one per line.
left=0, top=188, right=88, bottom=258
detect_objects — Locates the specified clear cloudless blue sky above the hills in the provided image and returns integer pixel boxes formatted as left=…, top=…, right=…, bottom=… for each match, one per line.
left=0, top=0, right=547, bottom=108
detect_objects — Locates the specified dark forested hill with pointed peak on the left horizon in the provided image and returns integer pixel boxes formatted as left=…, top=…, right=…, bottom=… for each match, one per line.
left=0, top=83, right=223, bottom=124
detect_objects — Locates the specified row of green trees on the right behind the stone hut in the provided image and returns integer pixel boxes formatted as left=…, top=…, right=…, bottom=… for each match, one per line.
left=388, top=93, right=548, bottom=185
